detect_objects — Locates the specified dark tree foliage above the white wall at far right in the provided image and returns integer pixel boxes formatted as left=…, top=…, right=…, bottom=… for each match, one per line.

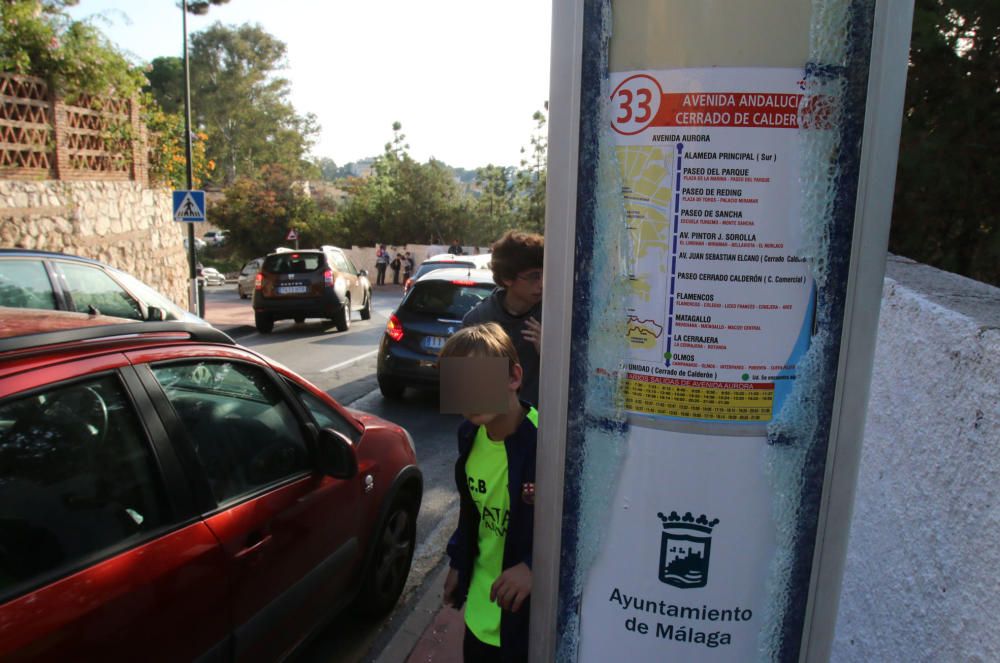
left=889, top=0, right=1000, bottom=283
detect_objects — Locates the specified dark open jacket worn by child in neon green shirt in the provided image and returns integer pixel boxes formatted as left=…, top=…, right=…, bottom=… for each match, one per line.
left=448, top=408, right=537, bottom=663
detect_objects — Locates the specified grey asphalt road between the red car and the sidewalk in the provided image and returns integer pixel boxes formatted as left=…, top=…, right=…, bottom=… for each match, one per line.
left=205, top=284, right=461, bottom=663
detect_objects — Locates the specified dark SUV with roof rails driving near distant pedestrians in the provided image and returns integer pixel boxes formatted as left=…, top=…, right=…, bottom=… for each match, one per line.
left=253, top=246, right=372, bottom=334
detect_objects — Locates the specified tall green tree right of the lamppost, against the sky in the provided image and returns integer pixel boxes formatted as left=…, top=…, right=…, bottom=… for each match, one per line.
left=180, top=23, right=319, bottom=185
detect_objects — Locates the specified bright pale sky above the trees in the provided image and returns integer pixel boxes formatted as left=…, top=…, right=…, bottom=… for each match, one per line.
left=69, top=0, right=552, bottom=169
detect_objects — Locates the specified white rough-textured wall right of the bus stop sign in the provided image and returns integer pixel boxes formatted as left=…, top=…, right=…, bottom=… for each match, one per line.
left=831, top=258, right=1000, bottom=663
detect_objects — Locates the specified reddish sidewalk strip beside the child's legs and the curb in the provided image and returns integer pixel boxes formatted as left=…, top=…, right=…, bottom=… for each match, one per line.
left=375, top=564, right=465, bottom=663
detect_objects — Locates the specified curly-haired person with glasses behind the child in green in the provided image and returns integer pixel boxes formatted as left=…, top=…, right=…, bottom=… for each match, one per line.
left=462, top=230, right=545, bottom=405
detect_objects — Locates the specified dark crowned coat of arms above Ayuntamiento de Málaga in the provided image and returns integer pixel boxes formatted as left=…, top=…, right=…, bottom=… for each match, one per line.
left=656, top=511, right=719, bottom=589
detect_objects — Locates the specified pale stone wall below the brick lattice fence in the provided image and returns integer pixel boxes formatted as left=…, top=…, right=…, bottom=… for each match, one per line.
left=0, top=180, right=188, bottom=308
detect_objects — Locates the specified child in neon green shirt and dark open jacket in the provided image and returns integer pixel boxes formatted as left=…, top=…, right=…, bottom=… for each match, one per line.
left=441, top=322, right=538, bottom=663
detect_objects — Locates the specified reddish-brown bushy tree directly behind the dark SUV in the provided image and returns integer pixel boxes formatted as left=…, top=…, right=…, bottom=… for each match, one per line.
left=208, top=164, right=350, bottom=258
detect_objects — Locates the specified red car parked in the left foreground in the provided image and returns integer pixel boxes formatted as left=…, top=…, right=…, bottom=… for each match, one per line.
left=0, top=308, right=423, bottom=661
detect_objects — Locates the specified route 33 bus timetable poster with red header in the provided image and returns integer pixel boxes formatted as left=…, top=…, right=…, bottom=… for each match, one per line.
left=610, top=68, right=814, bottom=429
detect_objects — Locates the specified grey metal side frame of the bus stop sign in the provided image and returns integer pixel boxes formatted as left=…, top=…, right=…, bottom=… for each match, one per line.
left=531, top=0, right=913, bottom=661
